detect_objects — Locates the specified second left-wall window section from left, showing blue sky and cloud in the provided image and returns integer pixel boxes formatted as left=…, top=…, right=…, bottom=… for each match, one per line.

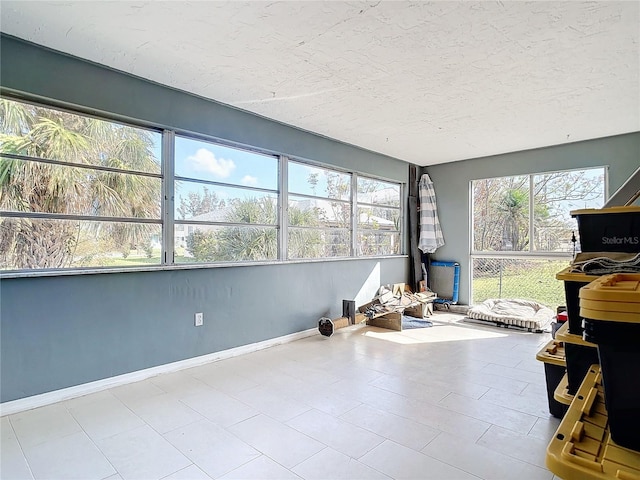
left=174, top=137, right=278, bottom=263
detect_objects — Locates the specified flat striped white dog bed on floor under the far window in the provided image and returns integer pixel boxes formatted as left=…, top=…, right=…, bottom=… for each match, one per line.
left=467, top=298, right=555, bottom=332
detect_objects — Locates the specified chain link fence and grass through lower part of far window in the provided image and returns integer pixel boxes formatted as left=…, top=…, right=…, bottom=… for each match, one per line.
left=472, top=257, right=570, bottom=310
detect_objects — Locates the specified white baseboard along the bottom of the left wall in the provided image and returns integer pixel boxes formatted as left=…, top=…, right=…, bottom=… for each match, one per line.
left=0, top=328, right=318, bottom=417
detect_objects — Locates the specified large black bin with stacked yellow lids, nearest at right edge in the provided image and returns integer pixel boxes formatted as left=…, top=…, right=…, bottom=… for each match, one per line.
left=580, top=273, right=640, bottom=450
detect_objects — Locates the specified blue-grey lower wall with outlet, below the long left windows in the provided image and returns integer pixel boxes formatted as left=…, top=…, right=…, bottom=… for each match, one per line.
left=0, top=258, right=408, bottom=402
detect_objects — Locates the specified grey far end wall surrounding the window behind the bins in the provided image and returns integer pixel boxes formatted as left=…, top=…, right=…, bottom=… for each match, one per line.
left=426, top=133, right=640, bottom=304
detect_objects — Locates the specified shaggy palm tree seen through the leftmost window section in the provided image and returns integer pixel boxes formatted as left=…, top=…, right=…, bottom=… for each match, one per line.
left=0, top=99, right=161, bottom=269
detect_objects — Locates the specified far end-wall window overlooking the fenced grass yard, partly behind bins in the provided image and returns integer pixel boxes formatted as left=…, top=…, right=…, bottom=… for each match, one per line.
left=471, top=168, right=606, bottom=306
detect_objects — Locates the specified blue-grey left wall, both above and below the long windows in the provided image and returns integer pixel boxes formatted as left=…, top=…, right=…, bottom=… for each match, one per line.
left=0, top=36, right=409, bottom=402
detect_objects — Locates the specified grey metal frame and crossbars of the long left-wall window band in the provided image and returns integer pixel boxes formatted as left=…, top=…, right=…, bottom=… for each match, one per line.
left=0, top=94, right=406, bottom=278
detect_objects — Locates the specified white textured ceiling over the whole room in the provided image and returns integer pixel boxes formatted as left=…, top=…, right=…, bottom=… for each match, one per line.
left=0, top=0, right=640, bottom=165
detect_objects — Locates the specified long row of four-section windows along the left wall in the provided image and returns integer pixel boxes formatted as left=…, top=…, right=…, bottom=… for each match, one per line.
left=0, top=99, right=402, bottom=271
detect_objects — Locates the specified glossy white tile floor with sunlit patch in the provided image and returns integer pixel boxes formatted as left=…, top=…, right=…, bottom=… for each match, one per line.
left=0, top=313, right=558, bottom=480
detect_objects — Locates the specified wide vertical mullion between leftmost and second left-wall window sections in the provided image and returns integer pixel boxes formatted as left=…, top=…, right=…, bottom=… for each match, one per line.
left=161, top=130, right=175, bottom=265
